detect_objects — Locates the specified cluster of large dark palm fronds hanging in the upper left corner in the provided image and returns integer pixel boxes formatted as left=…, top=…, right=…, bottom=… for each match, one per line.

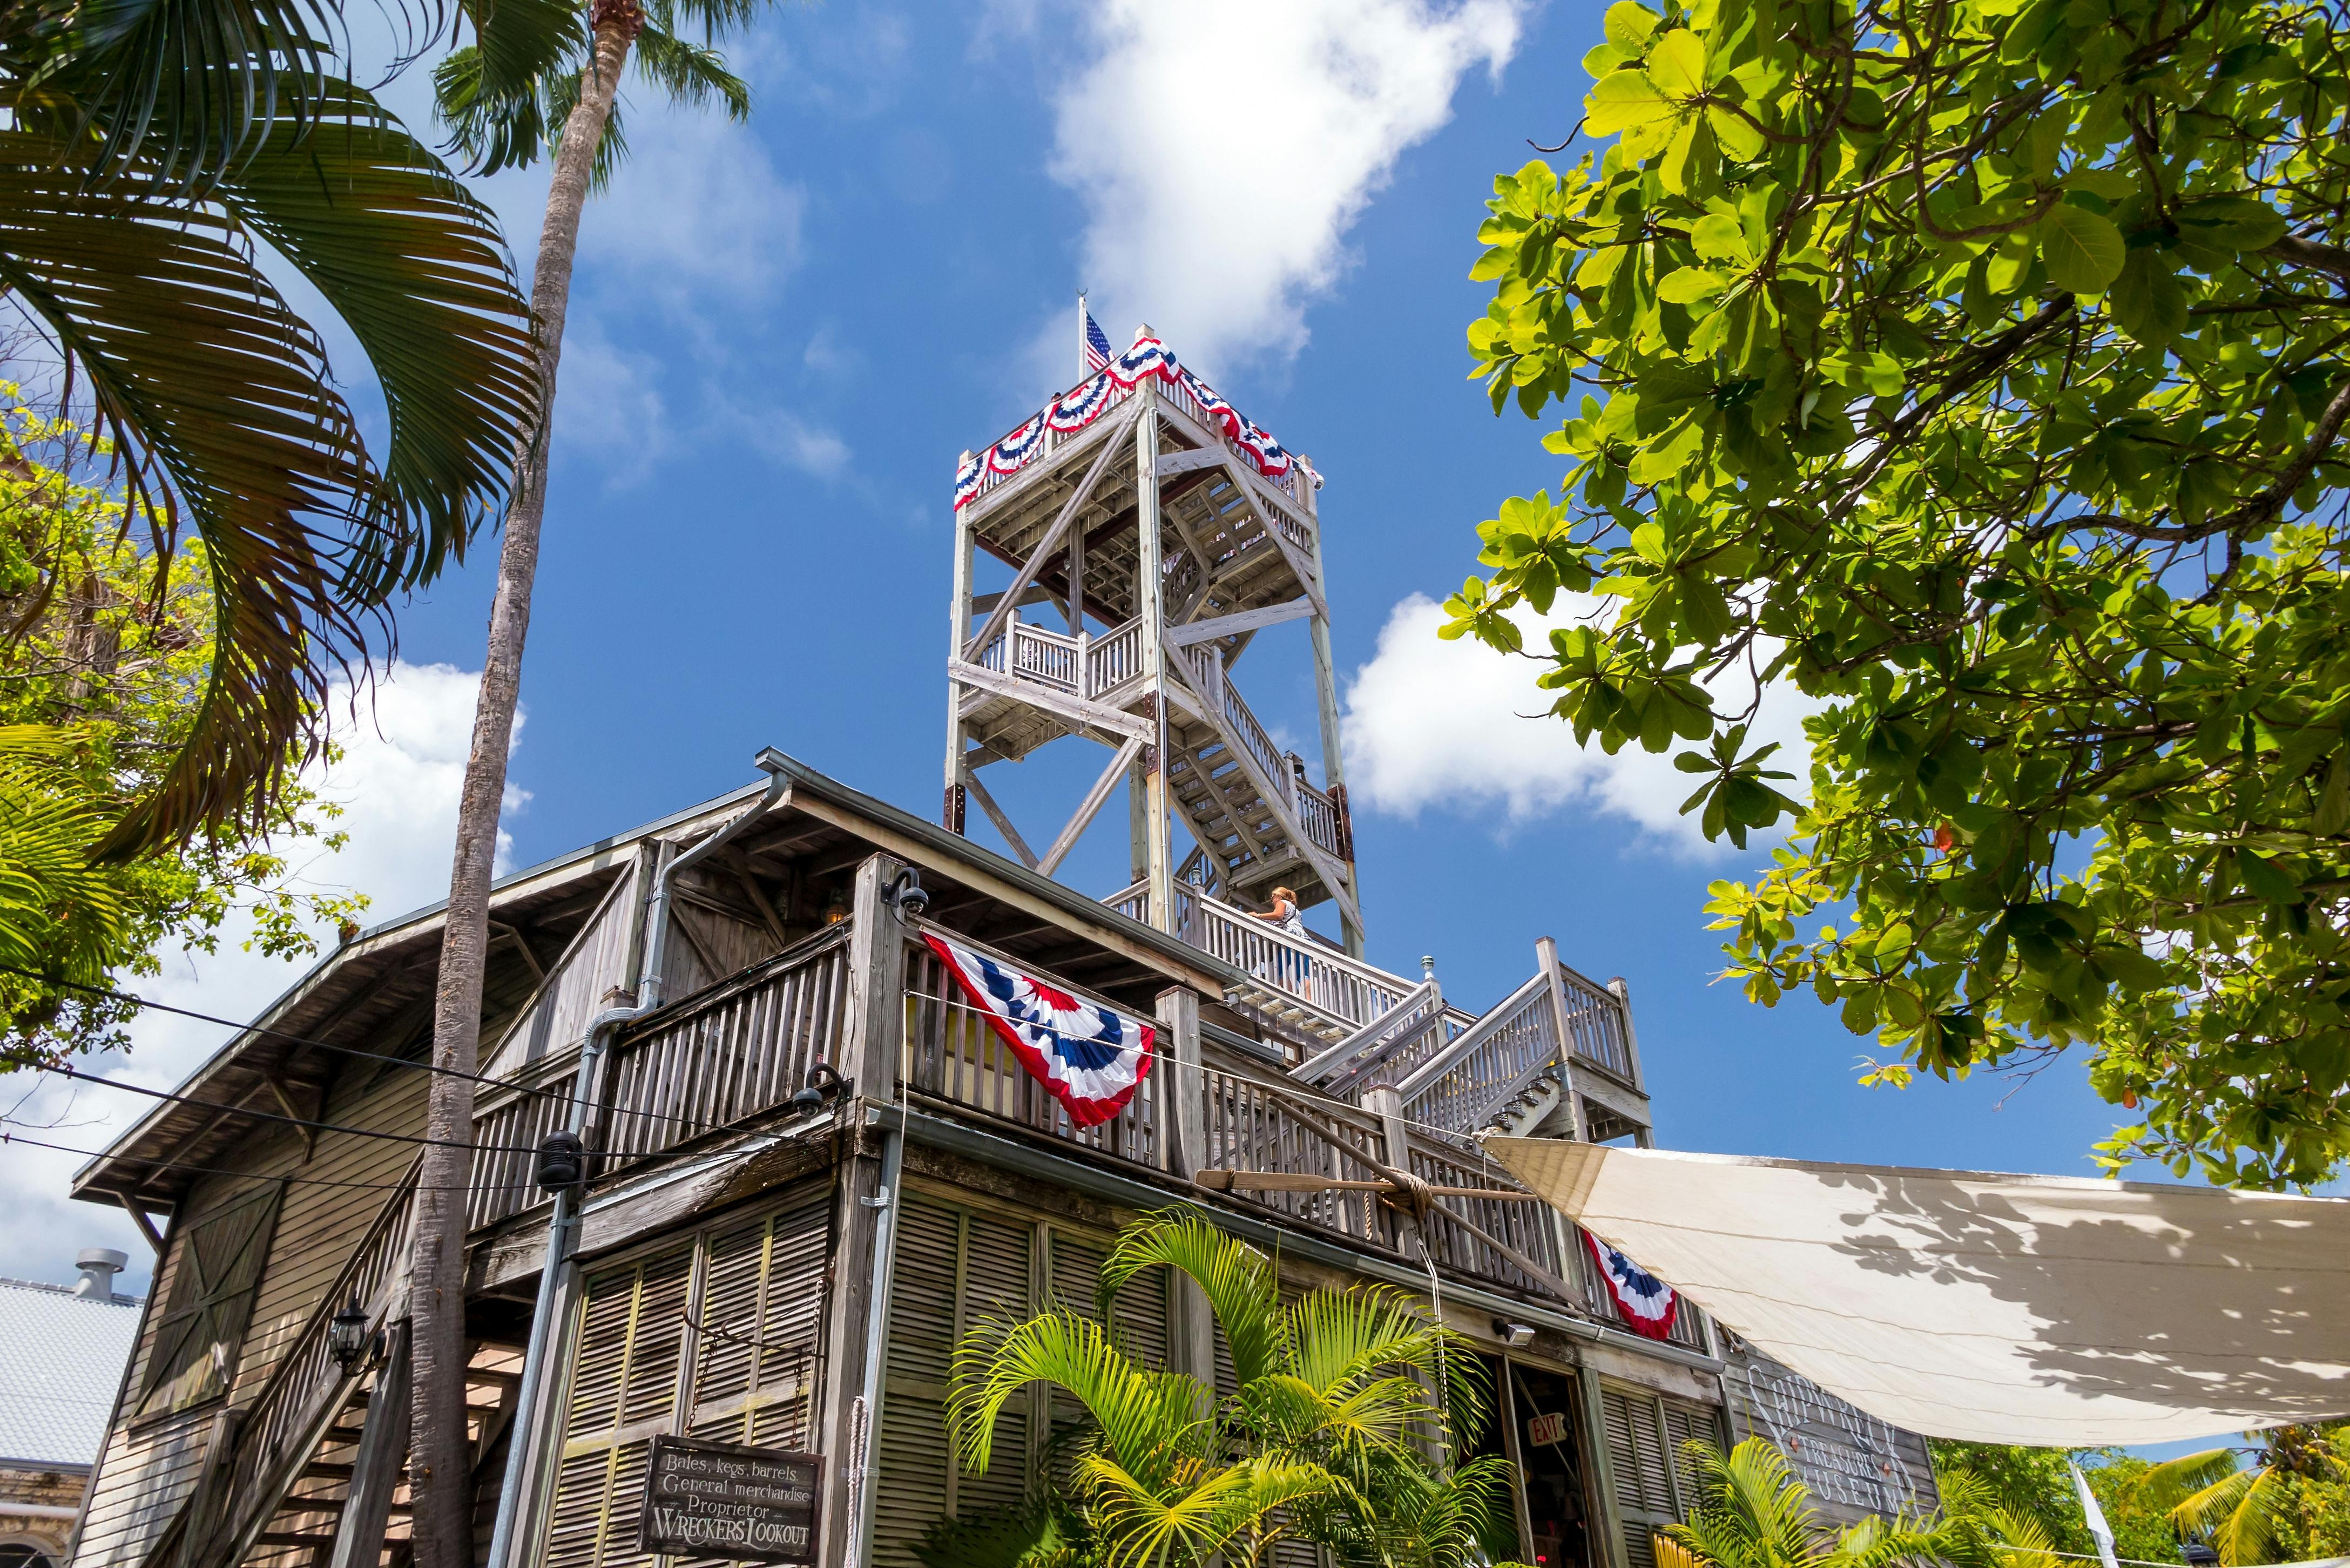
left=0, top=0, right=578, bottom=858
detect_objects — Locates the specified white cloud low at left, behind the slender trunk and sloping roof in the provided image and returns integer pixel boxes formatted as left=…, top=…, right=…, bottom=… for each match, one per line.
left=0, top=663, right=529, bottom=1290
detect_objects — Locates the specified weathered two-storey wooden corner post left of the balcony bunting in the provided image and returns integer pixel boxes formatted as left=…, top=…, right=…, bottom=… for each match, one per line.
left=815, top=856, right=905, bottom=1568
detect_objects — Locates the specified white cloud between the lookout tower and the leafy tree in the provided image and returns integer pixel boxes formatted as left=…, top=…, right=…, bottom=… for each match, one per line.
left=1344, top=595, right=1814, bottom=853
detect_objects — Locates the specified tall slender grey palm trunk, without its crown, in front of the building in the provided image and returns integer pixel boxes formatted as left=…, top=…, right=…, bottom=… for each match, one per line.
left=409, top=0, right=644, bottom=1568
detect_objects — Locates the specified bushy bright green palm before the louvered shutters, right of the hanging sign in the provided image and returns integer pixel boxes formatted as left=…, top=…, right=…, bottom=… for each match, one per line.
left=949, top=1211, right=1507, bottom=1568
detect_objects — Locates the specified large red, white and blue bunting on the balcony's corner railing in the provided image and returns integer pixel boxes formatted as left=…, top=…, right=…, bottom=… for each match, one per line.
left=921, top=931, right=1159, bottom=1126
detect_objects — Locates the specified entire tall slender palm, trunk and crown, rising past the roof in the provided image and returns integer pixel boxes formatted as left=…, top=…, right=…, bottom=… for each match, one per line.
left=409, top=0, right=764, bottom=1568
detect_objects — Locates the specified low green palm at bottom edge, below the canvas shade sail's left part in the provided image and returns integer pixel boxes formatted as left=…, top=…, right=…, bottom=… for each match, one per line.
left=1655, top=1436, right=2002, bottom=1568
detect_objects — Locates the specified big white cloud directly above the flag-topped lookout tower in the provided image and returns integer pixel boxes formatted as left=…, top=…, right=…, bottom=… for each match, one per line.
left=1046, top=0, right=1528, bottom=369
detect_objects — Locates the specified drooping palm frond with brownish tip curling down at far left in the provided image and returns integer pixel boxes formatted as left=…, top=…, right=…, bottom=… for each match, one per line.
left=0, top=132, right=376, bottom=856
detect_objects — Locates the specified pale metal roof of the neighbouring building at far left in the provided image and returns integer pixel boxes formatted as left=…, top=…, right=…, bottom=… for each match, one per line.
left=0, top=1279, right=139, bottom=1464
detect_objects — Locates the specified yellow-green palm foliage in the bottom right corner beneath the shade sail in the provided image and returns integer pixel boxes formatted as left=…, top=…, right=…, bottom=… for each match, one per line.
left=2136, top=1422, right=2350, bottom=1568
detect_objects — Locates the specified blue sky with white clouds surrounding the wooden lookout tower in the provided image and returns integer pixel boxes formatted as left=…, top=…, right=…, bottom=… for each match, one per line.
left=9, top=0, right=2162, bottom=1316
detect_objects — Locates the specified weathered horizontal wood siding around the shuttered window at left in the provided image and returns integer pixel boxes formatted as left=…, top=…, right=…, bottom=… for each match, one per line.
left=73, top=1058, right=428, bottom=1568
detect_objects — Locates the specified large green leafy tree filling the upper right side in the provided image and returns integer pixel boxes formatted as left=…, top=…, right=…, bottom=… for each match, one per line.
left=1445, top=0, right=2350, bottom=1187
